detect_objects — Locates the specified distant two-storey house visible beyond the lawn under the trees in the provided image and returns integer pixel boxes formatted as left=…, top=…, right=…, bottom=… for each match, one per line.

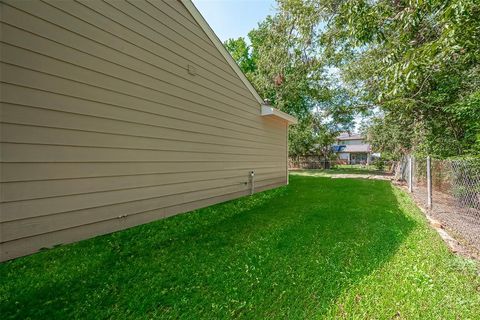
left=333, top=133, right=372, bottom=164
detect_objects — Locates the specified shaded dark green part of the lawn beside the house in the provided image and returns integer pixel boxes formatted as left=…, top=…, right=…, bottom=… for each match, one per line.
left=0, top=176, right=416, bottom=319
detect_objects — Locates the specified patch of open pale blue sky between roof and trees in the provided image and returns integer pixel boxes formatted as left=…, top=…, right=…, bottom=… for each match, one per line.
left=193, top=0, right=275, bottom=42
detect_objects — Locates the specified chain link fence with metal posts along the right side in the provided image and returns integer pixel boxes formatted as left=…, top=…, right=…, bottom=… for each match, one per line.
left=402, top=157, right=480, bottom=252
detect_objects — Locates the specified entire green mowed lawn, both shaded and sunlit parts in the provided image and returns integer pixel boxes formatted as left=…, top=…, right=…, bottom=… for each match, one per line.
left=0, top=175, right=480, bottom=319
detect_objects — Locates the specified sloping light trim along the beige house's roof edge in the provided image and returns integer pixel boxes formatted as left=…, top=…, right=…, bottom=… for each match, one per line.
left=179, top=0, right=263, bottom=104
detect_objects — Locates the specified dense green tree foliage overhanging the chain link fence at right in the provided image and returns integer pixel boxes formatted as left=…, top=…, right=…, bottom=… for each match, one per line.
left=322, top=0, right=480, bottom=157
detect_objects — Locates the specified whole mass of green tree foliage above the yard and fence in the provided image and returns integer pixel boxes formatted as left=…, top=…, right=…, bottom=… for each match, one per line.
left=226, top=0, right=480, bottom=158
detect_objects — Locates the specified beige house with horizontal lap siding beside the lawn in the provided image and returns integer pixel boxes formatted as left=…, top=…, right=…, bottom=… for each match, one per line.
left=0, top=0, right=296, bottom=260
